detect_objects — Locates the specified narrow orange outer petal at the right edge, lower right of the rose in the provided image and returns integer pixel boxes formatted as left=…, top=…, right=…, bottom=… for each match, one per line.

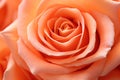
left=102, top=42, right=120, bottom=76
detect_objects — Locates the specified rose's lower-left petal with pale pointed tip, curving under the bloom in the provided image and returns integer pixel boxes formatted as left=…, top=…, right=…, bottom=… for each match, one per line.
left=18, top=40, right=78, bottom=75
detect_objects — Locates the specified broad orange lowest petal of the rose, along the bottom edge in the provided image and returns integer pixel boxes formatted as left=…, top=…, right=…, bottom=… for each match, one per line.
left=38, top=59, right=105, bottom=80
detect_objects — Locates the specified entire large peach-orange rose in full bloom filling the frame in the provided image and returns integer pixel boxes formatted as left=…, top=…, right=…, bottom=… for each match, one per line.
left=2, top=0, right=120, bottom=80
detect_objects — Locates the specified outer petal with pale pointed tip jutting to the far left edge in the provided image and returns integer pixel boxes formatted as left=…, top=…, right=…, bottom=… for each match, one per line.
left=0, top=20, right=28, bottom=70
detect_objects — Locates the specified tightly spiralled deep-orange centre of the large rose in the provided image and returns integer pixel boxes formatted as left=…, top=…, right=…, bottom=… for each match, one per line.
left=39, top=8, right=89, bottom=52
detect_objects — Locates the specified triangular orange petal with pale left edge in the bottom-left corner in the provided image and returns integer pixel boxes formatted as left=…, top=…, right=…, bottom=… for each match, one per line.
left=3, top=56, right=32, bottom=80
